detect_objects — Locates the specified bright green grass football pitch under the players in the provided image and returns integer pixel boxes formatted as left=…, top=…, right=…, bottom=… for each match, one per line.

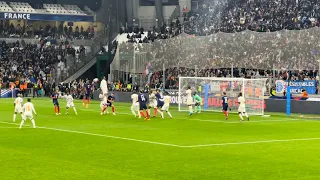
left=0, top=98, right=320, bottom=180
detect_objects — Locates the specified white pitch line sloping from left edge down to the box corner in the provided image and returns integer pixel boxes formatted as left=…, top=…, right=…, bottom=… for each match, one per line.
left=0, top=121, right=183, bottom=147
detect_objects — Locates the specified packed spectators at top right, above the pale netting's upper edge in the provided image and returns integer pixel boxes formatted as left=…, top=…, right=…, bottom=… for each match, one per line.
left=185, top=0, right=320, bottom=35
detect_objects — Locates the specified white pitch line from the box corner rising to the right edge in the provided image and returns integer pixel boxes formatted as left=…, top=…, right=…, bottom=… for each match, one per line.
left=183, top=138, right=320, bottom=148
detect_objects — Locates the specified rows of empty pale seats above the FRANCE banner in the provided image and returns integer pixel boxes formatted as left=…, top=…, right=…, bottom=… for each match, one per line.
left=0, top=1, right=91, bottom=15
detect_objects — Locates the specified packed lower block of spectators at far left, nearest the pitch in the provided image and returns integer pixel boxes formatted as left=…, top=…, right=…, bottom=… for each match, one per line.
left=0, top=40, right=84, bottom=96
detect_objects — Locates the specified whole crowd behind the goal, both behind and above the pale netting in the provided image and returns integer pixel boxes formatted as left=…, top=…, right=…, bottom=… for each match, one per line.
left=112, top=0, right=320, bottom=87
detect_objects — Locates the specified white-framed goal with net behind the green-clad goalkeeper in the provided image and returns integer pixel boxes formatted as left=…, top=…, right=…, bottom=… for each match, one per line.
left=178, top=77, right=267, bottom=115
